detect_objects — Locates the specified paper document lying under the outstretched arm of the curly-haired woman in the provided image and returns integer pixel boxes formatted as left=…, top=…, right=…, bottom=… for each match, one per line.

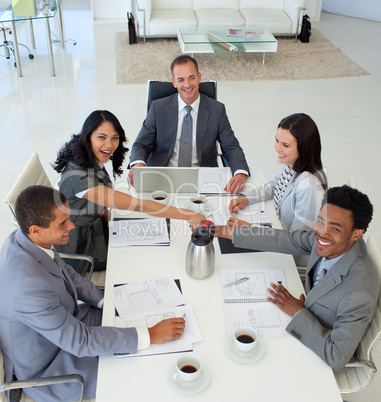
left=109, top=218, right=169, bottom=247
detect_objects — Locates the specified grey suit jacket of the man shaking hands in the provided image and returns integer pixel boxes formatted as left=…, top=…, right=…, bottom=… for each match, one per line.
left=233, top=227, right=379, bottom=368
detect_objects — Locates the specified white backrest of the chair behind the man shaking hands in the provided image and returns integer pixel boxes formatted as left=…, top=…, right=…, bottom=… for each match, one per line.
left=357, top=236, right=381, bottom=364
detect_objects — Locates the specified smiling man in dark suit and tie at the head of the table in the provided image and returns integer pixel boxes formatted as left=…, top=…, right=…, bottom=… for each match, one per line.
left=130, top=55, right=249, bottom=193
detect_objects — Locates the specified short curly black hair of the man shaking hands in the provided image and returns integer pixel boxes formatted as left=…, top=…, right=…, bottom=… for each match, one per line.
left=322, top=185, right=373, bottom=231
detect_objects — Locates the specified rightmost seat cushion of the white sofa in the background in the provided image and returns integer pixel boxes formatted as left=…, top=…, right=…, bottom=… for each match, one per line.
left=241, top=8, right=292, bottom=35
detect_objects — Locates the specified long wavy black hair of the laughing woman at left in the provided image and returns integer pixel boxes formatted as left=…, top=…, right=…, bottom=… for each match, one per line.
left=52, top=110, right=128, bottom=175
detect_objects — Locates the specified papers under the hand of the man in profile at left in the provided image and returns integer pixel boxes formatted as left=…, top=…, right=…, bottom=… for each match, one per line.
left=111, top=275, right=202, bottom=357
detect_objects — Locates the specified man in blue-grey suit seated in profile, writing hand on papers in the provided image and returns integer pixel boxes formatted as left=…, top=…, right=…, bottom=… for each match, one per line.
left=0, top=186, right=184, bottom=402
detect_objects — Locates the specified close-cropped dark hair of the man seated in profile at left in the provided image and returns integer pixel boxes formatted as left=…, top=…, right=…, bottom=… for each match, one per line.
left=15, top=186, right=67, bottom=235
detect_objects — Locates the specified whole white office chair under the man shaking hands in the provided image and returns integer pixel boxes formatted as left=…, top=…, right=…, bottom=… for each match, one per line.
left=335, top=236, right=381, bottom=394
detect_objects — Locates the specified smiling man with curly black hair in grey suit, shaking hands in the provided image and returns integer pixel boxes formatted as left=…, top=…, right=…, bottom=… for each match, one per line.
left=216, top=186, right=379, bottom=369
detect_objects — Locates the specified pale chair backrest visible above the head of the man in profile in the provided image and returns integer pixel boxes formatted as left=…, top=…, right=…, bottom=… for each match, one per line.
left=4, top=153, right=52, bottom=223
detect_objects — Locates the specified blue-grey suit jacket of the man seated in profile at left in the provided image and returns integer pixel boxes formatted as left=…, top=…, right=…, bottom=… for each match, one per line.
left=0, top=230, right=137, bottom=402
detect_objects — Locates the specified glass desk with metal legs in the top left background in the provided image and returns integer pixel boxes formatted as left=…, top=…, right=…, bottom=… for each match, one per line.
left=0, top=0, right=65, bottom=77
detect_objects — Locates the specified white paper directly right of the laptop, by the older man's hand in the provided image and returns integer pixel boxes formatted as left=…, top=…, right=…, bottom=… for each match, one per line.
left=198, top=167, right=232, bottom=194
